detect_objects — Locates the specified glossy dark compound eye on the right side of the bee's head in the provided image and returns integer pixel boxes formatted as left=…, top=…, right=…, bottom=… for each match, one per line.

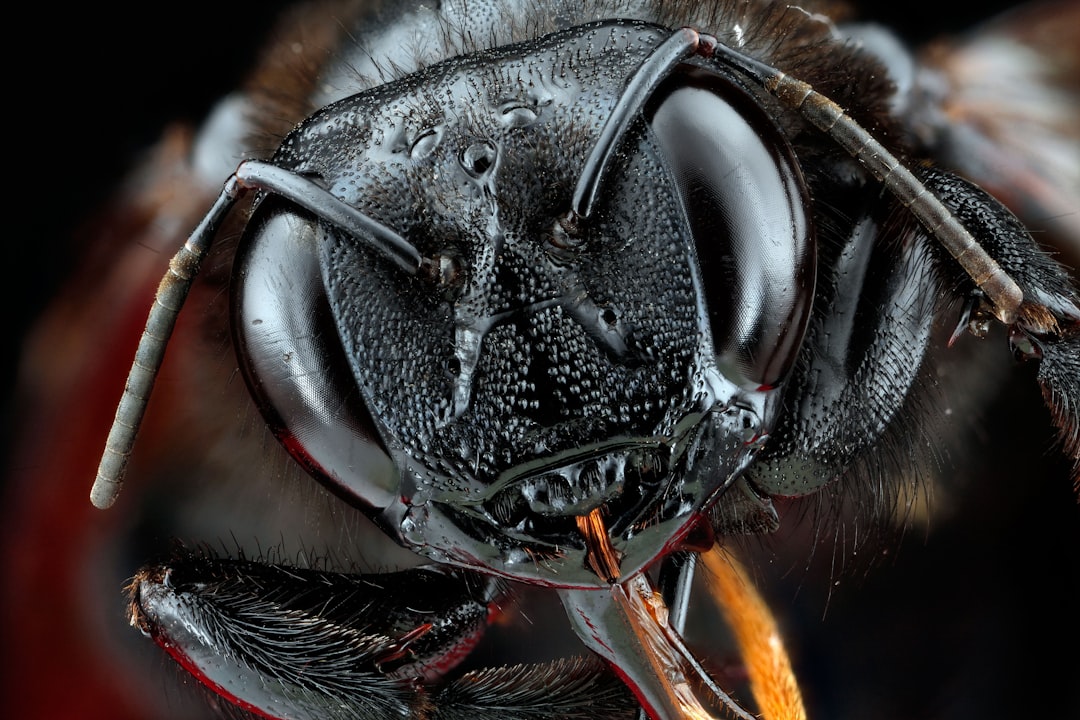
left=646, top=69, right=816, bottom=389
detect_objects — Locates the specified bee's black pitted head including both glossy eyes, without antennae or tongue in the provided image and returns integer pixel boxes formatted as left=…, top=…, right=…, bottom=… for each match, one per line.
left=232, top=22, right=814, bottom=586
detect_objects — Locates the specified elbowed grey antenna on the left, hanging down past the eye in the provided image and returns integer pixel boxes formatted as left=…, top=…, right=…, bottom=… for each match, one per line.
left=90, top=160, right=425, bottom=510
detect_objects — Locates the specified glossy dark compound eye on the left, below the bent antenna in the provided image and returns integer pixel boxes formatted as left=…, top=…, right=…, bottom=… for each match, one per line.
left=231, top=198, right=399, bottom=507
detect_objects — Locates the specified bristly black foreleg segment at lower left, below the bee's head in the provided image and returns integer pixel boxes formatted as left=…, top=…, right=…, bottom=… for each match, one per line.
left=130, top=552, right=503, bottom=719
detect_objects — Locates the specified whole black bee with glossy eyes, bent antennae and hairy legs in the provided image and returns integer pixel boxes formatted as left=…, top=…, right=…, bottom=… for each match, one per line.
left=73, top=2, right=1080, bottom=718
